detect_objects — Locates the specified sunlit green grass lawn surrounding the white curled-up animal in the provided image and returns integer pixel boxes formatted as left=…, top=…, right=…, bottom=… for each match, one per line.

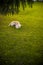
left=0, top=3, right=43, bottom=65
